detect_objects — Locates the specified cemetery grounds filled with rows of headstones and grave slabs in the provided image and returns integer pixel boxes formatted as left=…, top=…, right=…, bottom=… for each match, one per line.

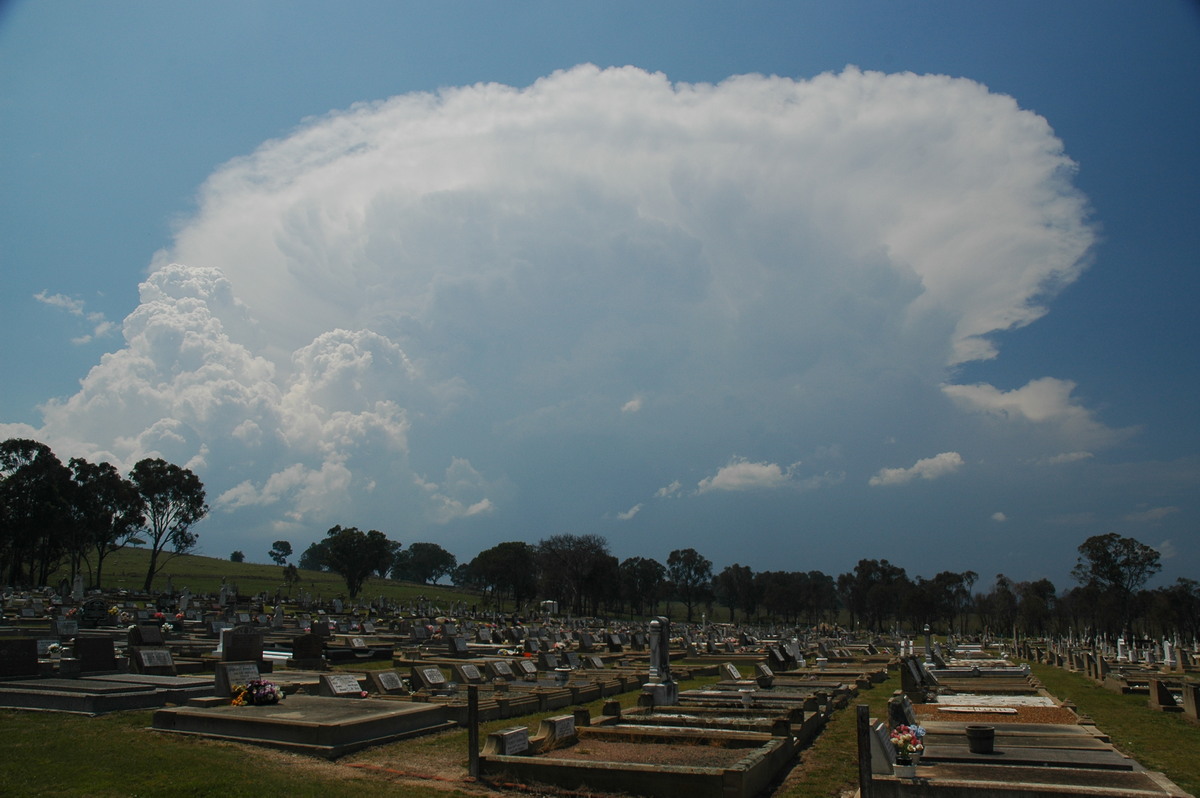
left=0, top=578, right=1200, bottom=798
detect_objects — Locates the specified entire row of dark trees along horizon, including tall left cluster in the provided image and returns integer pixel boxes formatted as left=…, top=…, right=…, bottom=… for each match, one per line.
left=7, top=438, right=1200, bottom=638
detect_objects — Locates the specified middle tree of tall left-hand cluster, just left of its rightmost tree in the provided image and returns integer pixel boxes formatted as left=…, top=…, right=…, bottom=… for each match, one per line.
left=71, top=457, right=145, bottom=587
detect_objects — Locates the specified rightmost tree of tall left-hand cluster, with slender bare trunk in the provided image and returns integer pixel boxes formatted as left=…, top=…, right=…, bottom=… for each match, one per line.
left=130, top=457, right=209, bottom=593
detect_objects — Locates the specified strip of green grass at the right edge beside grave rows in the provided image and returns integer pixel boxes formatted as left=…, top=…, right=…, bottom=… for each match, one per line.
left=1030, top=662, right=1200, bottom=794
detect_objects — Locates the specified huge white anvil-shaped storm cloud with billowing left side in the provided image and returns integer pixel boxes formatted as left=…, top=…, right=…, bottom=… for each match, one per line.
left=6, top=65, right=1103, bottom=553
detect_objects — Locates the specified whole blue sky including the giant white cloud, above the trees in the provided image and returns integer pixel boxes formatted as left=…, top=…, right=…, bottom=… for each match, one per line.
left=0, top=1, right=1200, bottom=588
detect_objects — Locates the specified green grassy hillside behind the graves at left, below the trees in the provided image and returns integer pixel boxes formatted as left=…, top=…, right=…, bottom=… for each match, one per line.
left=52, top=546, right=482, bottom=606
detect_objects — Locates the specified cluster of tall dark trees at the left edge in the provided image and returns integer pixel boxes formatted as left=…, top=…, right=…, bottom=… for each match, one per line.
left=0, top=438, right=209, bottom=592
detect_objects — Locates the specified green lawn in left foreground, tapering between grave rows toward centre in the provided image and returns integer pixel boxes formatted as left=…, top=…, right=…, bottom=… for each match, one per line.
left=0, top=678, right=715, bottom=798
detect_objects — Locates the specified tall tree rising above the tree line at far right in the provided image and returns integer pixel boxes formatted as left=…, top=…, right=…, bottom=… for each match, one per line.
left=1070, top=532, right=1163, bottom=632
